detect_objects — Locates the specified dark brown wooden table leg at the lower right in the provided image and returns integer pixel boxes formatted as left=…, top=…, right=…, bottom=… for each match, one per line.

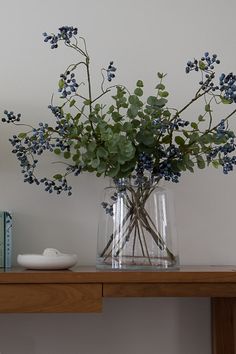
left=211, top=298, right=236, bottom=354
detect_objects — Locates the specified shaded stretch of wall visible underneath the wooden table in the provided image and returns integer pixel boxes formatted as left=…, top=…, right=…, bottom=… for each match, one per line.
left=0, top=298, right=211, bottom=354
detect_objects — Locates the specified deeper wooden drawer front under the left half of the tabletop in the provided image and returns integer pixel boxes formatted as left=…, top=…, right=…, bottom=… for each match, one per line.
left=0, top=284, right=102, bottom=313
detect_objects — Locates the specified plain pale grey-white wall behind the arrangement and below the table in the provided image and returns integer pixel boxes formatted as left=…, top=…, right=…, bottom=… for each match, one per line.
left=0, top=0, right=236, bottom=354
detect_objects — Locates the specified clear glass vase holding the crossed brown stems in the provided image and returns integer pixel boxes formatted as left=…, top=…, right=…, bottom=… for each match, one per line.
left=97, top=179, right=179, bottom=270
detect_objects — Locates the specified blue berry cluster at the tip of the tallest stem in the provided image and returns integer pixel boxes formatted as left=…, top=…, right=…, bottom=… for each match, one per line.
left=43, top=26, right=78, bottom=49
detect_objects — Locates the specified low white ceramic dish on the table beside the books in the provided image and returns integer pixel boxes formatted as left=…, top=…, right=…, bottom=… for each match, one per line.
left=17, top=248, right=78, bottom=270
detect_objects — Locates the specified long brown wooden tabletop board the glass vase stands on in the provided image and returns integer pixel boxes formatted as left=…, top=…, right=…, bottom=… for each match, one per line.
left=0, top=266, right=236, bottom=284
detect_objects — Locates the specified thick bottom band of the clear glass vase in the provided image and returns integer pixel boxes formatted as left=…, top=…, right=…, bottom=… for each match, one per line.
left=96, top=256, right=179, bottom=271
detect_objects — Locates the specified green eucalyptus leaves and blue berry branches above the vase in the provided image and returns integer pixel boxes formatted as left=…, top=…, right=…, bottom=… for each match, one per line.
left=2, top=26, right=236, bottom=195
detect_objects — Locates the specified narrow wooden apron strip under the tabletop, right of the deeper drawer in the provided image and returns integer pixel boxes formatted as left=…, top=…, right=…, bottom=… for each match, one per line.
left=103, top=283, right=236, bottom=297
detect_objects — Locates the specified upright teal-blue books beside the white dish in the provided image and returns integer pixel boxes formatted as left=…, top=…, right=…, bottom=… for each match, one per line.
left=0, top=211, right=12, bottom=268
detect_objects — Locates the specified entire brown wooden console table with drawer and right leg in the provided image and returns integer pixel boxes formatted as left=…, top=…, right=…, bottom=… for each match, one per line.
left=0, top=266, right=236, bottom=354
